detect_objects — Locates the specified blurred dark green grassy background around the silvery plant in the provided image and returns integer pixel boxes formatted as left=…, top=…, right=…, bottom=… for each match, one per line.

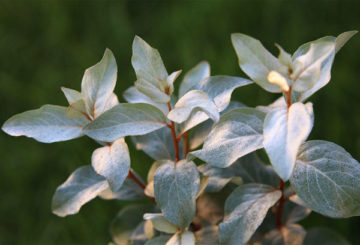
left=0, top=0, right=360, bottom=245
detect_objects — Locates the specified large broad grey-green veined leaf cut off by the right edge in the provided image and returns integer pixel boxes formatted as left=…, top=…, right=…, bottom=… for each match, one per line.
left=290, top=140, right=360, bottom=218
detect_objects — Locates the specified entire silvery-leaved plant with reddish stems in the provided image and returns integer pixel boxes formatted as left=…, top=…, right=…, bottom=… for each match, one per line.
left=2, top=31, right=360, bottom=245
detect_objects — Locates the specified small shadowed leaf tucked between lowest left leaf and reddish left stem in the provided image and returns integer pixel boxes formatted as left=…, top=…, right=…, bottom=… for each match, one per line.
left=99, top=177, right=145, bottom=201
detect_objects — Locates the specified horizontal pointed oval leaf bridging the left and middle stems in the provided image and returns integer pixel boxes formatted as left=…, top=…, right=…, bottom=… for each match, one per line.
left=84, top=103, right=166, bottom=142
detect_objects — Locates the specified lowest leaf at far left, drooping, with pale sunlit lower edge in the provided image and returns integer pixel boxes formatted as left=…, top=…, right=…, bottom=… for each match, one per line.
left=52, top=166, right=108, bottom=217
